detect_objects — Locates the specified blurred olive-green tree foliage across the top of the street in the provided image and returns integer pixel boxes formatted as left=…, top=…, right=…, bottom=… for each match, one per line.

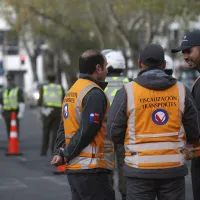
left=1, top=0, right=200, bottom=85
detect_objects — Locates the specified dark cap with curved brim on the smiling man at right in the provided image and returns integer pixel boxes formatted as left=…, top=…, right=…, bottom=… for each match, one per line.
left=171, top=30, right=200, bottom=53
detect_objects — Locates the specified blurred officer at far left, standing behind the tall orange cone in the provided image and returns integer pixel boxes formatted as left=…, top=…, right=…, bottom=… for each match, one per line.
left=0, top=72, right=25, bottom=138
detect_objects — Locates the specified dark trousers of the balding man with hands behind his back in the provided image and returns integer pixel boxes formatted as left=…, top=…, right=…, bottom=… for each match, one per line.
left=67, top=173, right=115, bottom=200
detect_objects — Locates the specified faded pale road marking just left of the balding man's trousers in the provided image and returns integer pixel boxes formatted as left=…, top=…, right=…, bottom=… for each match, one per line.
left=24, top=176, right=69, bottom=186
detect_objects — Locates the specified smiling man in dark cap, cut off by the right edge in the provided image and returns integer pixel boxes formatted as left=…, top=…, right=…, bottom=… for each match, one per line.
left=171, top=30, right=200, bottom=200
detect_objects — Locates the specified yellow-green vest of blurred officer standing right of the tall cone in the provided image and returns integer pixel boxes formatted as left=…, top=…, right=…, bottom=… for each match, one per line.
left=43, top=83, right=63, bottom=108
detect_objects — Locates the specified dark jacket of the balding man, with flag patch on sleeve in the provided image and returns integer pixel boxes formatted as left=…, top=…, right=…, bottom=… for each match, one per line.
left=54, top=74, right=110, bottom=173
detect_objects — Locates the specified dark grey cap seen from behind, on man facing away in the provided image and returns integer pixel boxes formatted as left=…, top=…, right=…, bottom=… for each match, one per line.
left=139, top=44, right=165, bottom=67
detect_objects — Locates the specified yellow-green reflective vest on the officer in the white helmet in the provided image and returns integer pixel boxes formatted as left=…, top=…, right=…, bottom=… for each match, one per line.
left=104, top=76, right=129, bottom=104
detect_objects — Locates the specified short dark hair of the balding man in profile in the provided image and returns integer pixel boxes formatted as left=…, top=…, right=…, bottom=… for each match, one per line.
left=79, top=49, right=105, bottom=74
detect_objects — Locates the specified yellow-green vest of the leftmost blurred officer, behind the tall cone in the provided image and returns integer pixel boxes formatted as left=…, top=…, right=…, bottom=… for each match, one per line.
left=3, top=88, right=19, bottom=110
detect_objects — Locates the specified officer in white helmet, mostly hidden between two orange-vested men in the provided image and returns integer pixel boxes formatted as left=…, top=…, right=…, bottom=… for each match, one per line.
left=102, top=49, right=129, bottom=200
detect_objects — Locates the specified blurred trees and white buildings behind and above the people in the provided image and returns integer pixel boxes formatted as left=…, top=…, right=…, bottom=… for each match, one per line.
left=0, top=0, right=200, bottom=101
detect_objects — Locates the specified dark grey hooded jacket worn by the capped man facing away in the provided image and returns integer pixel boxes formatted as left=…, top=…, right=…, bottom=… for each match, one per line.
left=107, top=69, right=200, bottom=178
